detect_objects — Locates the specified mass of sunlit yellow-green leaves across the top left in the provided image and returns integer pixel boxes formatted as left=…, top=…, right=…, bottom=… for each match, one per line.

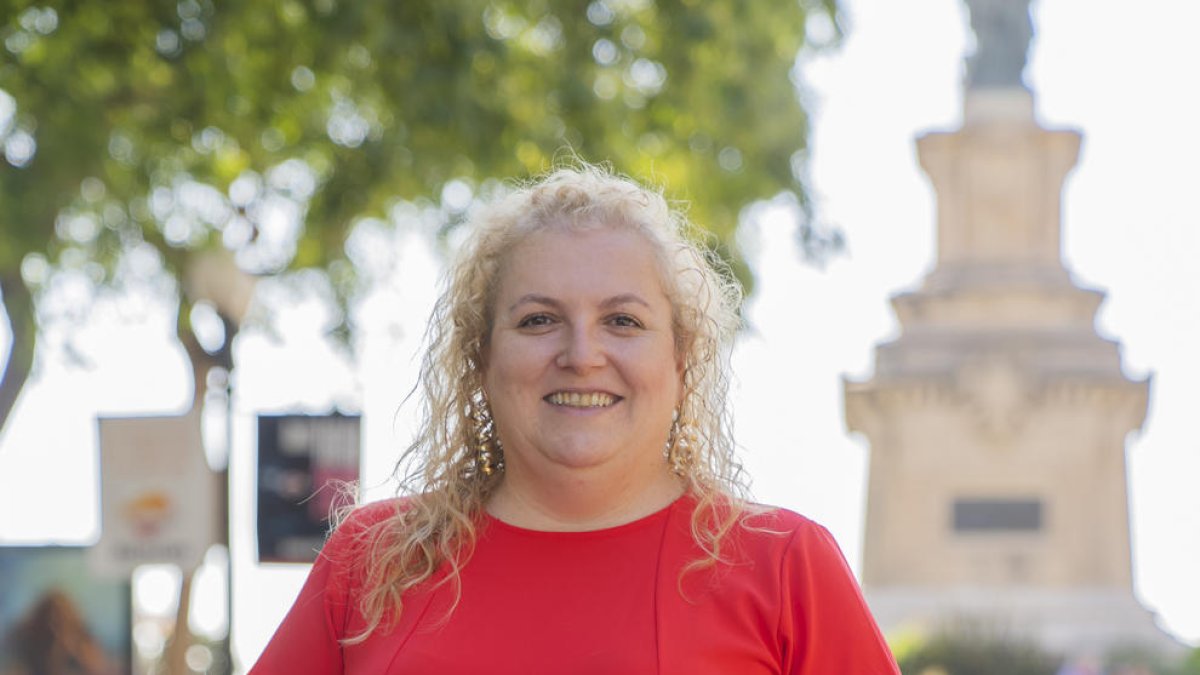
left=0, top=0, right=832, bottom=273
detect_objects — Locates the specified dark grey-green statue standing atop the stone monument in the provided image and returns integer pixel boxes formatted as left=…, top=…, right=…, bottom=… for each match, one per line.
left=966, top=0, right=1033, bottom=89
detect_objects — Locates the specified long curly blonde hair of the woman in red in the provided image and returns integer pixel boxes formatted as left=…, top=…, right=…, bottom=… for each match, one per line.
left=347, top=162, right=754, bottom=644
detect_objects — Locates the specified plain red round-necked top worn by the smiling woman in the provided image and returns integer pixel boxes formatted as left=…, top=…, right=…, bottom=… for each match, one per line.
left=251, top=497, right=900, bottom=675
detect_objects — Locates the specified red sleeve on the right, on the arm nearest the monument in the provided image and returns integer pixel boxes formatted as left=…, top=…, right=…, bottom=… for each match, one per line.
left=780, top=520, right=900, bottom=675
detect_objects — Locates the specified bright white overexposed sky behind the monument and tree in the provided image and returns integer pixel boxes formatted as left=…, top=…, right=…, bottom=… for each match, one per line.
left=0, top=0, right=1200, bottom=665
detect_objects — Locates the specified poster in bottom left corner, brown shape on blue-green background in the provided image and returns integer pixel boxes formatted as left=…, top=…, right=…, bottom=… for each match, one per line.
left=0, top=546, right=132, bottom=675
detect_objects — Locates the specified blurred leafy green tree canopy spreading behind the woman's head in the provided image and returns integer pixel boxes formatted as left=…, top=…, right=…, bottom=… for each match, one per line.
left=0, top=0, right=838, bottom=437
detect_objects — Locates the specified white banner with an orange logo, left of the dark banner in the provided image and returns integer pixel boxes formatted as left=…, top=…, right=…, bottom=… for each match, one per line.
left=90, top=414, right=217, bottom=577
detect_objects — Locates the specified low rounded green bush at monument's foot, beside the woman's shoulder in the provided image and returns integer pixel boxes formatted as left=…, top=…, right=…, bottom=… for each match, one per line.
left=896, top=626, right=1062, bottom=675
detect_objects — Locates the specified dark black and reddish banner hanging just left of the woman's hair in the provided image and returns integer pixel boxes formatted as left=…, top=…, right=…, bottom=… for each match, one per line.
left=258, top=414, right=360, bottom=562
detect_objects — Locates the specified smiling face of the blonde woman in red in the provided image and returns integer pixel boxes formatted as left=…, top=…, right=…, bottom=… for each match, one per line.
left=484, top=228, right=682, bottom=482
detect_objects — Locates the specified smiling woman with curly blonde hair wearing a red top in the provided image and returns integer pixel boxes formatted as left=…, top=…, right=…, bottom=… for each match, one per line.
left=253, top=167, right=899, bottom=675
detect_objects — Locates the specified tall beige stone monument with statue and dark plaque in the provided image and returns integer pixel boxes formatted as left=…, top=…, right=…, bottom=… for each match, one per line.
left=845, top=0, right=1178, bottom=656
